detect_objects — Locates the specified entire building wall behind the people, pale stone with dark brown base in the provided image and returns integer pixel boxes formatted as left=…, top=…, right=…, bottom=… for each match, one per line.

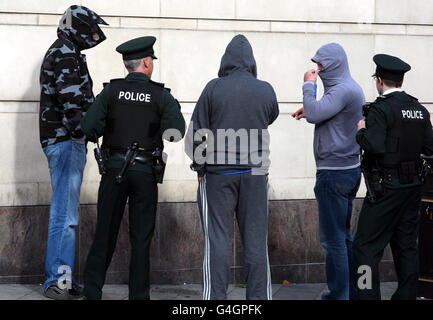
left=0, top=0, right=433, bottom=284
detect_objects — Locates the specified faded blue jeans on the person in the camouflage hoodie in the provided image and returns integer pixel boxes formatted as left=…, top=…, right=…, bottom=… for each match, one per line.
left=43, top=140, right=86, bottom=288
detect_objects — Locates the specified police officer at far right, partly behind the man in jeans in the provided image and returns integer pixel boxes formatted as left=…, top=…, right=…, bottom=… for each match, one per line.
left=353, top=54, right=433, bottom=300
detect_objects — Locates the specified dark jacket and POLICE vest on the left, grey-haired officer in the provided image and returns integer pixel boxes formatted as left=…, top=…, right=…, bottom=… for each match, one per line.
left=81, top=72, right=185, bottom=173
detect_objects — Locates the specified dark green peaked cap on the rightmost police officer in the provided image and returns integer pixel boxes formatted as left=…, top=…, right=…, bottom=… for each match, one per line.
left=373, top=54, right=410, bottom=81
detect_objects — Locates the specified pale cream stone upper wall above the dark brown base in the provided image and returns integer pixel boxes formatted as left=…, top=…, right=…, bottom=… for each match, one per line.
left=0, top=0, right=433, bottom=206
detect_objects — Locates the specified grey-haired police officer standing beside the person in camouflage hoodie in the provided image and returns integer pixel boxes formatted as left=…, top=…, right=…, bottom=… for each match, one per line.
left=81, top=37, right=185, bottom=299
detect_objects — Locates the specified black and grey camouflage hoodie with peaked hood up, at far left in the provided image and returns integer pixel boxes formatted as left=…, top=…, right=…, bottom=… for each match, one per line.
left=39, top=5, right=107, bottom=147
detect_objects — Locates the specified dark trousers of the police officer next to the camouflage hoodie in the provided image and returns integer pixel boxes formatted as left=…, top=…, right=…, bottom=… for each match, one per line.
left=84, top=169, right=158, bottom=300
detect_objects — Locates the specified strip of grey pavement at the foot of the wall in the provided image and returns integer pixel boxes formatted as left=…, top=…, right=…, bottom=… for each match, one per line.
left=0, top=282, right=406, bottom=300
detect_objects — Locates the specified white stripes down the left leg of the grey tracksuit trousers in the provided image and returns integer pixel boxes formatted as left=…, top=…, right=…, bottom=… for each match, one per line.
left=200, top=176, right=211, bottom=300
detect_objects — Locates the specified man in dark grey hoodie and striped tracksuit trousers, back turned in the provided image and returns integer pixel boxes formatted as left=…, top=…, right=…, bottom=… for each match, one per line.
left=185, top=35, right=279, bottom=300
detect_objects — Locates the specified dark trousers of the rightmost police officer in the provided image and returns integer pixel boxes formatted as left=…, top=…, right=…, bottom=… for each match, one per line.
left=353, top=186, right=421, bottom=300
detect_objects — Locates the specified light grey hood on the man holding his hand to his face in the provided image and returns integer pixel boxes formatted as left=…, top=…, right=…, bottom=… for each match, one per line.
left=311, top=42, right=351, bottom=88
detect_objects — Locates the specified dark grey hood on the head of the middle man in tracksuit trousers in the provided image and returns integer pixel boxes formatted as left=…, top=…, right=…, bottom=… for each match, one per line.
left=218, top=34, right=257, bottom=77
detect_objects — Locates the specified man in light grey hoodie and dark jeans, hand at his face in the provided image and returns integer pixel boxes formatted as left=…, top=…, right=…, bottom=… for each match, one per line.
left=293, top=43, right=365, bottom=300
